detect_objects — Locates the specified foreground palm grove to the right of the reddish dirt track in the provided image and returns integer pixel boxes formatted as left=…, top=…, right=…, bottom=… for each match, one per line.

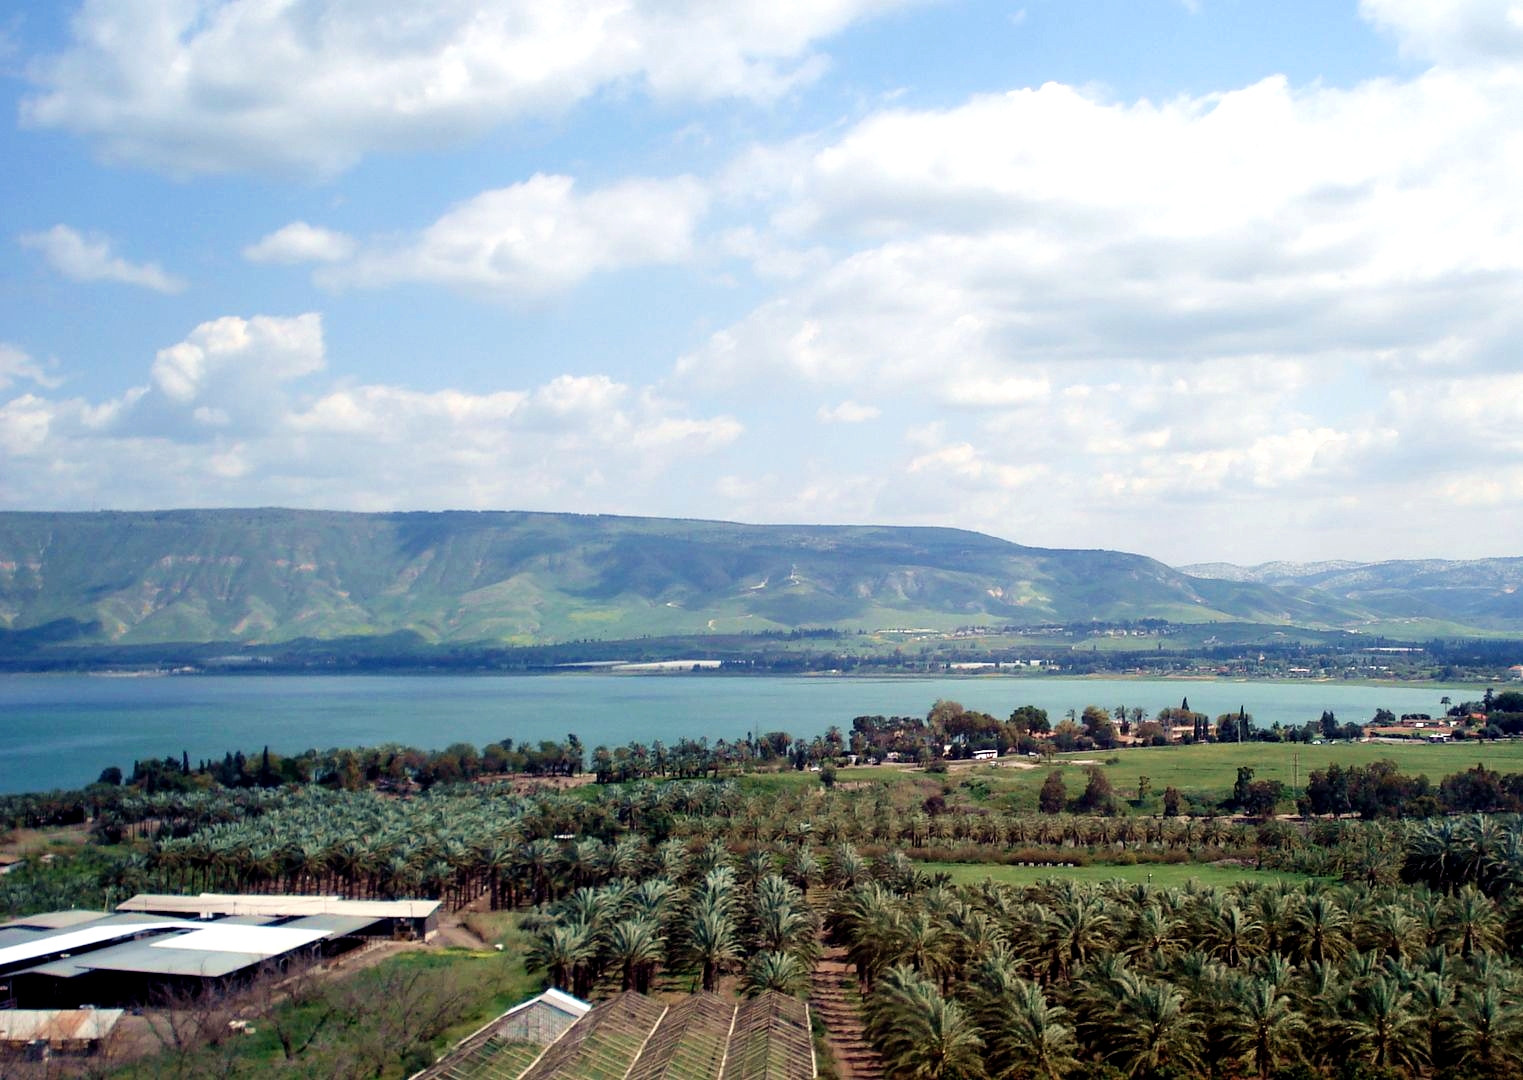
left=829, top=880, right=1523, bottom=1080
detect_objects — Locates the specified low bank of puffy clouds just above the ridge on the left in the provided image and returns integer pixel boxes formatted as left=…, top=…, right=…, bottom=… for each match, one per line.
left=0, top=314, right=743, bottom=512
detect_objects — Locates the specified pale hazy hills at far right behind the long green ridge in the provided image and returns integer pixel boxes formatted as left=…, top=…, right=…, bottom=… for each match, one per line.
left=1180, top=559, right=1523, bottom=629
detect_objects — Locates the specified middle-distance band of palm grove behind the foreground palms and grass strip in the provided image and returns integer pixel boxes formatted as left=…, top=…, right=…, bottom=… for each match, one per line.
left=107, top=770, right=1523, bottom=908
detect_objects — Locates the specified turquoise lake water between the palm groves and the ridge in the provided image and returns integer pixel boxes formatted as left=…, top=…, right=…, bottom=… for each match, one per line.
left=0, top=673, right=1479, bottom=792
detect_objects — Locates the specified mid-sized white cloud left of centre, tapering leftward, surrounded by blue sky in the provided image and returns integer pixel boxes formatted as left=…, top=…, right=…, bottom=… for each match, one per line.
left=327, top=175, right=707, bottom=300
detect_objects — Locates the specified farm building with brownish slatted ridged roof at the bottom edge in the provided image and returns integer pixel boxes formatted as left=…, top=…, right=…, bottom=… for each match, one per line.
left=414, top=990, right=816, bottom=1080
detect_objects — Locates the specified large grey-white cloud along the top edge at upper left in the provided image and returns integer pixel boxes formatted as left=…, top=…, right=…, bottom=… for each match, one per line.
left=21, top=0, right=905, bottom=175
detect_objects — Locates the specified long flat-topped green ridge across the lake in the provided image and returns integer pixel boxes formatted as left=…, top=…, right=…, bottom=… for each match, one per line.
left=0, top=510, right=1369, bottom=644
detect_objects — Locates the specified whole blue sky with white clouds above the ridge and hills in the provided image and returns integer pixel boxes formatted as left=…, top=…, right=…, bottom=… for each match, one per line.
left=0, top=0, right=1523, bottom=565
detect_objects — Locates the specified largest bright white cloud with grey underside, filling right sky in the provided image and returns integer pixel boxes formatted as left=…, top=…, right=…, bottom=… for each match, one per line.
left=694, top=63, right=1523, bottom=399
